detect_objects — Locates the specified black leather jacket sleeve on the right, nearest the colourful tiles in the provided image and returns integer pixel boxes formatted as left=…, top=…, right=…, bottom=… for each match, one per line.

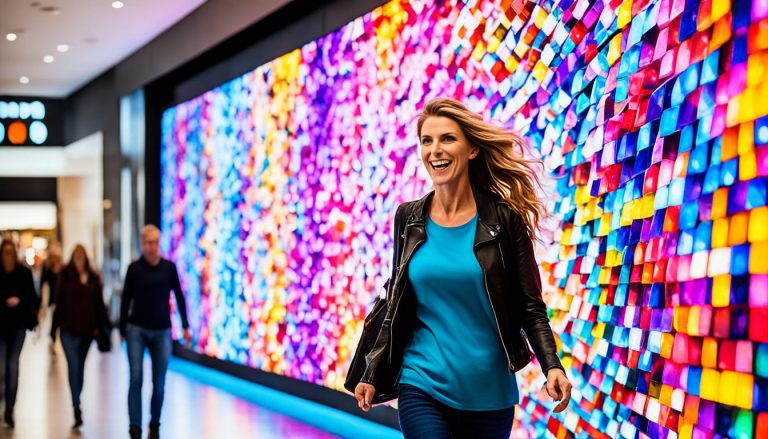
left=509, top=212, right=565, bottom=374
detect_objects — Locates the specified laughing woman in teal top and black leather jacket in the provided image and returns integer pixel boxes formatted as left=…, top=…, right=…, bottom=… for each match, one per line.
left=355, top=99, right=571, bottom=438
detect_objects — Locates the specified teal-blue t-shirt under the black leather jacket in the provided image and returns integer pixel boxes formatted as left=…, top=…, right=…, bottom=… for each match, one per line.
left=400, top=215, right=519, bottom=410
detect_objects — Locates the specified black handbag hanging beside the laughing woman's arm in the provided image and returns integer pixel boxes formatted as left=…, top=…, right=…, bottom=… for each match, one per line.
left=344, top=281, right=397, bottom=404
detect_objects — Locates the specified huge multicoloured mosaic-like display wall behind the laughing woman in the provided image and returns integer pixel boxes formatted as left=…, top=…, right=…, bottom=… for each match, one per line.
left=162, top=0, right=768, bottom=438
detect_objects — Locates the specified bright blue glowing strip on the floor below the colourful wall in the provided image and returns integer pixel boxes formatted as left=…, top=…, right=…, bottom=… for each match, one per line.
left=170, top=358, right=403, bottom=439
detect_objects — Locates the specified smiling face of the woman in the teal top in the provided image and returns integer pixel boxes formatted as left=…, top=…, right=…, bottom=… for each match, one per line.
left=419, top=116, right=479, bottom=186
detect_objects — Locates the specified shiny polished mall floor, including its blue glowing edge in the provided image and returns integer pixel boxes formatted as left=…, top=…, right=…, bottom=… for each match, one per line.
left=0, top=316, right=402, bottom=439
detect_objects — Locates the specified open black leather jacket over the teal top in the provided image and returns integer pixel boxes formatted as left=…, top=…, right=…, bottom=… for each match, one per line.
left=361, top=189, right=563, bottom=399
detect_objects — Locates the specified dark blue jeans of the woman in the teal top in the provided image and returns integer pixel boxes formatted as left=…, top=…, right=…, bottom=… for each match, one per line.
left=397, top=384, right=515, bottom=439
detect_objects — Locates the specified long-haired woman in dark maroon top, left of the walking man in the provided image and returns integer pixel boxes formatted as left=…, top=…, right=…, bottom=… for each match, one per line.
left=51, top=245, right=107, bottom=428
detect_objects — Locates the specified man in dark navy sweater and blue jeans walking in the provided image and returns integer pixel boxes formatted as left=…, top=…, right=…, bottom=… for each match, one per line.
left=120, top=225, right=192, bottom=438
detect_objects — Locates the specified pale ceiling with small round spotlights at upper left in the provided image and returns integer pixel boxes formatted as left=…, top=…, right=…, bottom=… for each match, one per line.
left=0, top=0, right=206, bottom=98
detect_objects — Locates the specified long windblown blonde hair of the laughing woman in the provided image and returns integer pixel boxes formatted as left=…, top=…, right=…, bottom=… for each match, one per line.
left=418, top=98, right=546, bottom=237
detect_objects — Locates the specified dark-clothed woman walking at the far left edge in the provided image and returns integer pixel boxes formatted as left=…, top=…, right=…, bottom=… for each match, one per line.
left=0, top=239, right=39, bottom=428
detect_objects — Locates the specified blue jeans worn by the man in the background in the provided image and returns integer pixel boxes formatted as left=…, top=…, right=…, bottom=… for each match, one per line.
left=125, top=324, right=171, bottom=428
